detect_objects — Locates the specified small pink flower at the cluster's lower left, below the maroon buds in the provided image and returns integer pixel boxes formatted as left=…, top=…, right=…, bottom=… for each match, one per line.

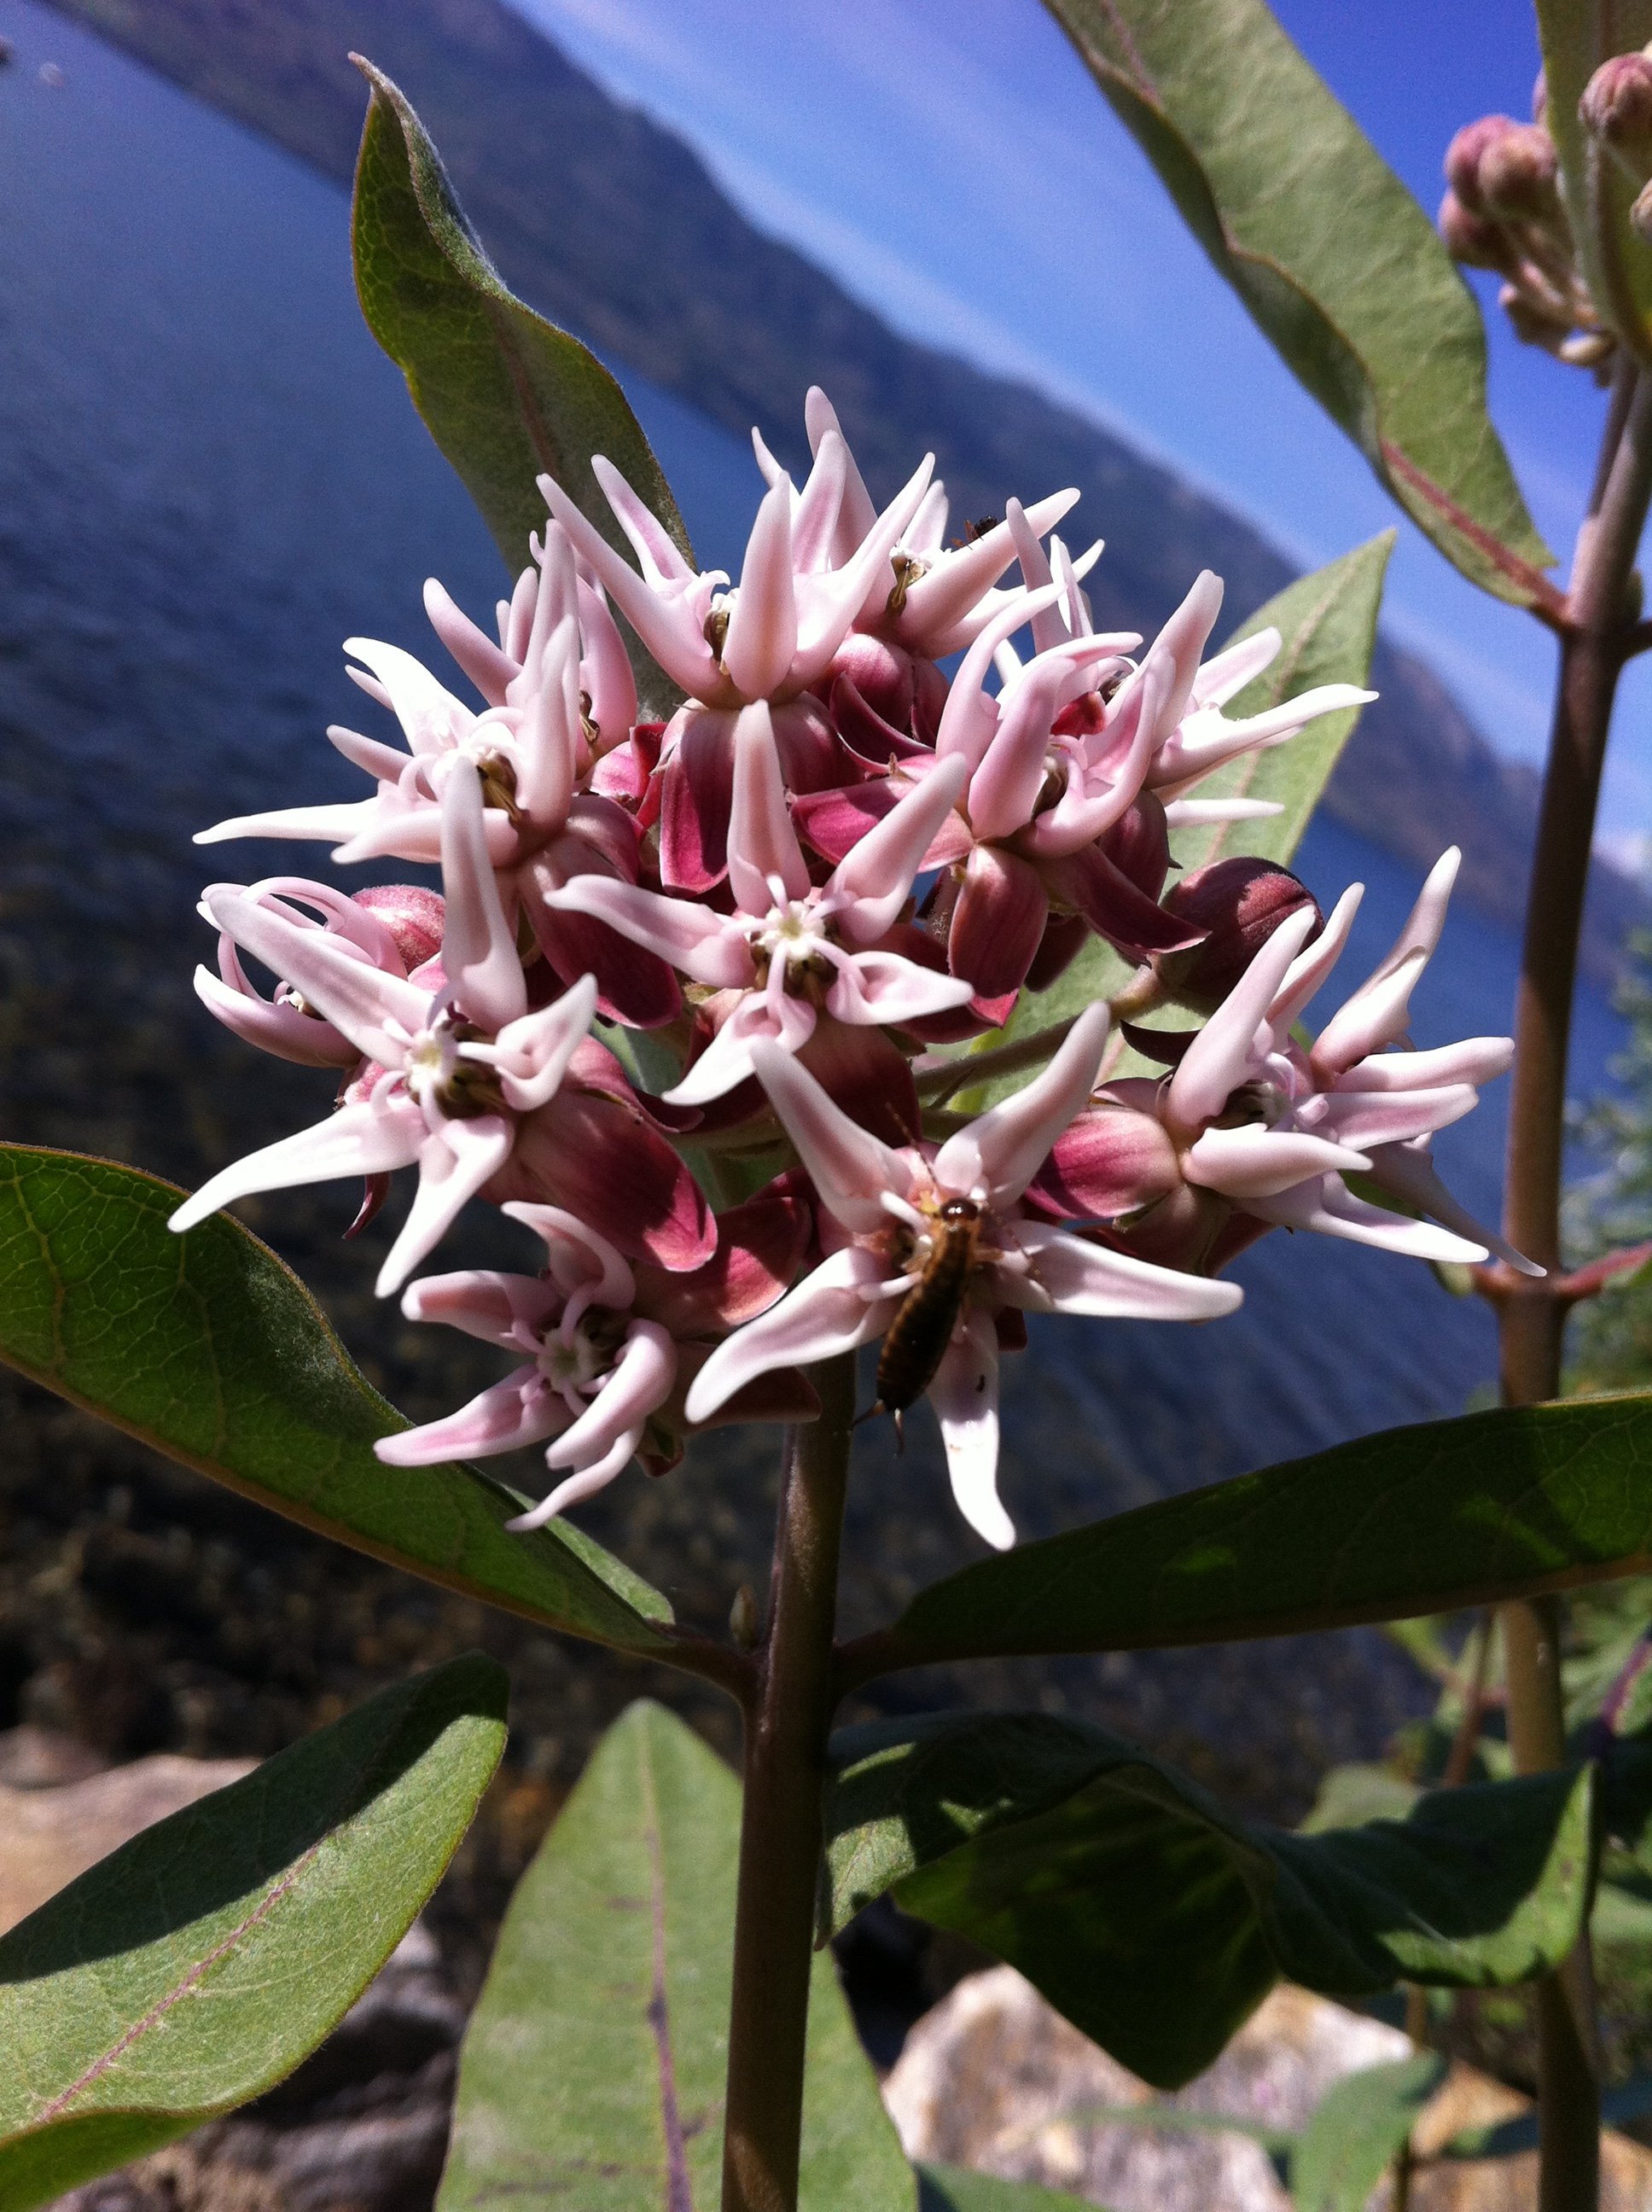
left=374, top=1192, right=818, bottom=1528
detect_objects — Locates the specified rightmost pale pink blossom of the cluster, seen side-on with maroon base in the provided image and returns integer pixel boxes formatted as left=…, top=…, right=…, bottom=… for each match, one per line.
left=1032, top=849, right=1528, bottom=1267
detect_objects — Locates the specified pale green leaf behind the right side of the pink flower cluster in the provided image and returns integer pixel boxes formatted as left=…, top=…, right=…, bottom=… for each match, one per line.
left=957, top=531, right=1393, bottom=1110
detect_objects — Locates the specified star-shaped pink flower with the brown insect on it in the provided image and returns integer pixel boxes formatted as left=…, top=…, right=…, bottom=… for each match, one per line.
left=685, top=1006, right=1241, bottom=1548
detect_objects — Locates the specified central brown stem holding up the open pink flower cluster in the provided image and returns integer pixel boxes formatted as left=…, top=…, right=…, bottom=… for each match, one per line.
left=723, top=1353, right=853, bottom=2212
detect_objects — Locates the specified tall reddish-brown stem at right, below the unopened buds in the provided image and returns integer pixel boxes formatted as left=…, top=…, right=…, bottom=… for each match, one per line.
left=1499, top=370, right=1652, bottom=2212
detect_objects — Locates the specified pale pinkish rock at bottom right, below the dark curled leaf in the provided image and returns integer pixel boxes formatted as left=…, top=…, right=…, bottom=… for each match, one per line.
left=885, top=1966, right=1652, bottom=2212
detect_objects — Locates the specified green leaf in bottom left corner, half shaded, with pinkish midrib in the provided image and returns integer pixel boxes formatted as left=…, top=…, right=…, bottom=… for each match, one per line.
left=0, top=1652, right=509, bottom=2212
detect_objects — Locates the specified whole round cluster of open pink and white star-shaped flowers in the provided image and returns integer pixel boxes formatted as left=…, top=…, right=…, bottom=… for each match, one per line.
left=172, top=392, right=1510, bottom=1544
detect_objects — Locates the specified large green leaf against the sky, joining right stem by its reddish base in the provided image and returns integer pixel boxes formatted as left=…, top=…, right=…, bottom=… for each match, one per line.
left=1048, top=0, right=1548, bottom=604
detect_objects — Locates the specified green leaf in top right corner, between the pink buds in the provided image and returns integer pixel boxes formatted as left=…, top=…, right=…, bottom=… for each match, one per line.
left=1537, top=0, right=1652, bottom=360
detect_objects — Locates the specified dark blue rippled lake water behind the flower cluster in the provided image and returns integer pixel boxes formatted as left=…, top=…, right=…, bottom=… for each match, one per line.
left=0, top=0, right=1617, bottom=1528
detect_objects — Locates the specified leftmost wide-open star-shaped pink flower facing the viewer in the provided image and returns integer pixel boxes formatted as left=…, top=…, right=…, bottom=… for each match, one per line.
left=171, top=759, right=597, bottom=1299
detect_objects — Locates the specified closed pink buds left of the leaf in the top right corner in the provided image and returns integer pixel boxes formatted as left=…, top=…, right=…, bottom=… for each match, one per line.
left=1440, top=84, right=1638, bottom=378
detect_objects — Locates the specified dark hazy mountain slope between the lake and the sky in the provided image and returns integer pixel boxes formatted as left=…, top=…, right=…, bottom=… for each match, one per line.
left=51, top=0, right=1645, bottom=978
